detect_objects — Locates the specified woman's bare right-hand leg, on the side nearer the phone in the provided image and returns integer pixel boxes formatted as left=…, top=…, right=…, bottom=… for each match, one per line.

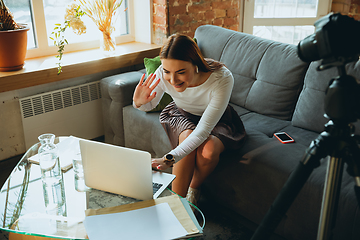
left=190, top=135, right=225, bottom=189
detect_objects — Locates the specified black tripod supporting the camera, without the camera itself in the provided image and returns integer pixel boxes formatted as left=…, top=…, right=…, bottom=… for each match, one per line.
left=251, top=63, right=360, bottom=240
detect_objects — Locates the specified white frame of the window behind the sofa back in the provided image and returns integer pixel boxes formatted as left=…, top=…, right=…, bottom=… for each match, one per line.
left=243, top=0, right=332, bottom=40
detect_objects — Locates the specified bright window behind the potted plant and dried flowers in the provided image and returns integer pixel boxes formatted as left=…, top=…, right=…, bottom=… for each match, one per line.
left=5, top=0, right=134, bottom=58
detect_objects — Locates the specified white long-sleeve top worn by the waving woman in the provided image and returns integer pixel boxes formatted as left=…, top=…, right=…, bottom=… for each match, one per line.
left=133, top=65, right=234, bottom=162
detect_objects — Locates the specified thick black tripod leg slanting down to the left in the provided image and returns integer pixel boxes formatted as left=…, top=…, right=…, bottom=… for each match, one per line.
left=251, top=139, right=326, bottom=240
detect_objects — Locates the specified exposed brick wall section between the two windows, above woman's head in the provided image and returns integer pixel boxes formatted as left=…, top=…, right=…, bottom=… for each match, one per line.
left=153, top=0, right=241, bottom=44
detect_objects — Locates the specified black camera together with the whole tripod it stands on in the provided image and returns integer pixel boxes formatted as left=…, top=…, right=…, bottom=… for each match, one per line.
left=251, top=13, right=360, bottom=240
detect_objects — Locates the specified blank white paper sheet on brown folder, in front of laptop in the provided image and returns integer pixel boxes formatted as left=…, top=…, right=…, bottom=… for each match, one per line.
left=84, top=203, right=187, bottom=240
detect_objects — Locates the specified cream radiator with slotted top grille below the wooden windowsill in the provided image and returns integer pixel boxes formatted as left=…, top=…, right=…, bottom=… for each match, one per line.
left=19, top=81, right=104, bottom=149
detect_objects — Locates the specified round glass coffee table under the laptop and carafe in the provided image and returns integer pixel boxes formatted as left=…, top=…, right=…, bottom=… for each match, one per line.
left=0, top=137, right=193, bottom=240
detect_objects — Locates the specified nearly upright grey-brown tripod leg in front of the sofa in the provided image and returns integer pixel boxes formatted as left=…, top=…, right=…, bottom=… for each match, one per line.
left=317, top=157, right=344, bottom=240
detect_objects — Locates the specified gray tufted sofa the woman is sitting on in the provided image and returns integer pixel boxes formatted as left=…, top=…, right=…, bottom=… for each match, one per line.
left=101, top=25, right=360, bottom=240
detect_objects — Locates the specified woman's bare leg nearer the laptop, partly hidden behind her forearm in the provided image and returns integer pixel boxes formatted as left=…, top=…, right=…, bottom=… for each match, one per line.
left=172, top=130, right=196, bottom=197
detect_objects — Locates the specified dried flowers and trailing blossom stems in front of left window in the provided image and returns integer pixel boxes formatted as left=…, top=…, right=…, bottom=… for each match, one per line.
left=50, top=0, right=123, bottom=74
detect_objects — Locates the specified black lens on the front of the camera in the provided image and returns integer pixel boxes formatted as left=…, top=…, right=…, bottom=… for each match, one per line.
left=298, top=33, right=320, bottom=62
